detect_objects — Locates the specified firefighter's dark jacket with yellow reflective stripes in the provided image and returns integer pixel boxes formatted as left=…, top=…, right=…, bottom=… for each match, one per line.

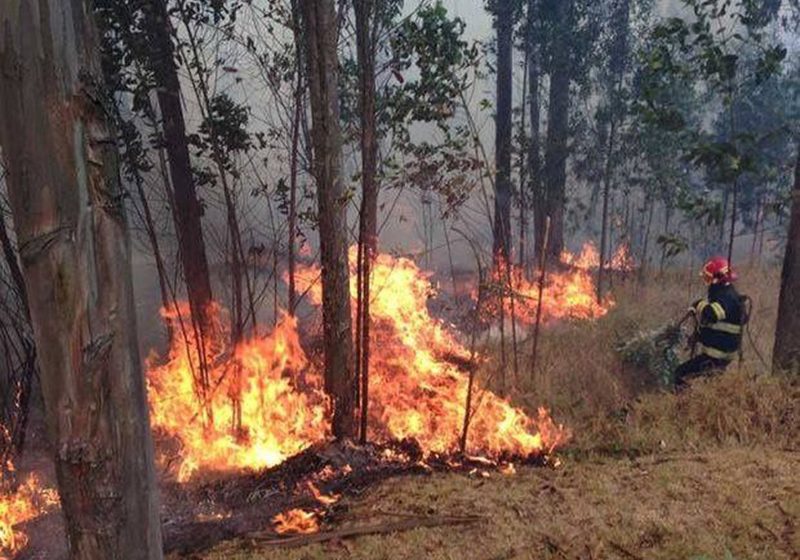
left=692, top=284, right=745, bottom=362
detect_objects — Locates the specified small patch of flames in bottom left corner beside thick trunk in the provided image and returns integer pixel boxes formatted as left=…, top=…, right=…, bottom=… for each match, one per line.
left=0, top=465, right=58, bottom=559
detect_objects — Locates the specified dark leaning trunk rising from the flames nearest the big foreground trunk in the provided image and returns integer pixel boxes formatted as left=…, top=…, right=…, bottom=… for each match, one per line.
left=143, top=0, right=212, bottom=333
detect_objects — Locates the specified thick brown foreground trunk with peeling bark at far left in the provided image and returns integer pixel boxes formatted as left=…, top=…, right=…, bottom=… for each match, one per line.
left=0, top=0, right=162, bottom=560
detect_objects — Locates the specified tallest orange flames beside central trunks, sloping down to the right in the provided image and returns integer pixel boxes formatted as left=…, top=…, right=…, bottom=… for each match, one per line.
left=297, top=248, right=567, bottom=456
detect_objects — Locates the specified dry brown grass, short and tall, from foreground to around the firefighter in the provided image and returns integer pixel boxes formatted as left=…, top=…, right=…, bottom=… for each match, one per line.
left=188, top=271, right=800, bottom=560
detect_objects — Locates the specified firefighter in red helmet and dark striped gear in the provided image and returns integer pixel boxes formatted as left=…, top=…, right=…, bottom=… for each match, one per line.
left=675, top=257, right=746, bottom=389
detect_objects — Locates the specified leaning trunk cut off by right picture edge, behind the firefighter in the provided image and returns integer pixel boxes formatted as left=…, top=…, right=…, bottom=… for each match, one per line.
left=772, top=149, right=800, bottom=373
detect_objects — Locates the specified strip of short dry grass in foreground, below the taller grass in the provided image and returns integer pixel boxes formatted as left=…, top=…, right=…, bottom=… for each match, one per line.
left=194, top=448, right=800, bottom=560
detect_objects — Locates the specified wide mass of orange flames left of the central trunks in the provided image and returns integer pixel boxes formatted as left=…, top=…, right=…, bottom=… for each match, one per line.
left=148, top=304, right=329, bottom=481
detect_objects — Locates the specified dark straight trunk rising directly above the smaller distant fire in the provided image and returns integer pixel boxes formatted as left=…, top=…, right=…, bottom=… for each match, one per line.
left=493, top=0, right=514, bottom=263
